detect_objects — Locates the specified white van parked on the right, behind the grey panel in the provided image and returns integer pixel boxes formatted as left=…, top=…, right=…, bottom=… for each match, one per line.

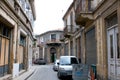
left=57, top=56, right=78, bottom=79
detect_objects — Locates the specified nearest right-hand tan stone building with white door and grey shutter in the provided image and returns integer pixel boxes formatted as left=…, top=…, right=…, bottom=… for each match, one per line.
left=63, top=0, right=120, bottom=80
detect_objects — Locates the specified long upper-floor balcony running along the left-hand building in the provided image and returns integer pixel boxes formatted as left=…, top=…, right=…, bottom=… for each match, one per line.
left=0, top=0, right=33, bottom=34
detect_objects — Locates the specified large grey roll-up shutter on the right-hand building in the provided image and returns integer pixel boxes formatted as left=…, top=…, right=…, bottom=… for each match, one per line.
left=86, top=28, right=97, bottom=65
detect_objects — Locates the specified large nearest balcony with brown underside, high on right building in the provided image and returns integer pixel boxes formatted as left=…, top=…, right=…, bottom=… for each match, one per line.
left=75, top=0, right=94, bottom=26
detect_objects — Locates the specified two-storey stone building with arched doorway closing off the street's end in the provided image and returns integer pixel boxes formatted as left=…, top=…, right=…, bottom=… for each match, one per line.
left=34, top=30, right=63, bottom=63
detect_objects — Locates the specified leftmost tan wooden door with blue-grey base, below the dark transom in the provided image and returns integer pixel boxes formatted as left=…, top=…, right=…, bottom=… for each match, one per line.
left=0, top=36, right=9, bottom=76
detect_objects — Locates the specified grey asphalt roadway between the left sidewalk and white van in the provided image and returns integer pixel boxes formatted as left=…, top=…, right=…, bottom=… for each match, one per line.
left=27, top=65, right=59, bottom=80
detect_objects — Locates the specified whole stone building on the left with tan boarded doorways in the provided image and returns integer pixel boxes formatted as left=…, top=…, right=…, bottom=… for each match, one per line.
left=0, top=0, right=36, bottom=78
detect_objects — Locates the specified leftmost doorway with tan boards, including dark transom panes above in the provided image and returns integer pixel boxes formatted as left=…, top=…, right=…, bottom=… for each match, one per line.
left=0, top=23, right=11, bottom=77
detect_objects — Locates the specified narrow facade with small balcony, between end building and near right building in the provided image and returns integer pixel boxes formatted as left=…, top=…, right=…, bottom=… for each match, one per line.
left=63, top=2, right=81, bottom=59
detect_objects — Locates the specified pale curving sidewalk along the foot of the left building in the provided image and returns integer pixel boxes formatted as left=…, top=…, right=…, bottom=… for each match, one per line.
left=13, top=65, right=36, bottom=80
